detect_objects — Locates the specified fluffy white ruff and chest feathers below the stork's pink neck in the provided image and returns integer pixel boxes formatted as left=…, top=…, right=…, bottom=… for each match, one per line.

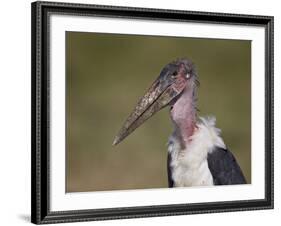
left=168, top=117, right=225, bottom=187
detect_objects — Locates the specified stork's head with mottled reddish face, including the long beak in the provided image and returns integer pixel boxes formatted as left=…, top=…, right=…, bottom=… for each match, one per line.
left=113, top=59, right=197, bottom=145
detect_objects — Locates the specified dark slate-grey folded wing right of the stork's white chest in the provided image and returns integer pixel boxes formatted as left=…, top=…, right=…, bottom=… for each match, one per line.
left=207, top=147, right=247, bottom=185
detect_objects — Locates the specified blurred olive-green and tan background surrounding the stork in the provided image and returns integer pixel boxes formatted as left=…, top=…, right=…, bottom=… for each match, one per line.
left=66, top=32, right=251, bottom=192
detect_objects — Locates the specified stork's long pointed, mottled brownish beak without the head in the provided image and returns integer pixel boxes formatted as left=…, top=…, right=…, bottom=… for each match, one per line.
left=112, top=76, right=180, bottom=145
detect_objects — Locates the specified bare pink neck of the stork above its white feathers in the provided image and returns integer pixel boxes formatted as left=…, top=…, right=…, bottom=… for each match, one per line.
left=170, top=89, right=196, bottom=144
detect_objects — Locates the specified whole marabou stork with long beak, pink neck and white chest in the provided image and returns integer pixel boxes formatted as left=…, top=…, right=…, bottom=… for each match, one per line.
left=113, top=58, right=246, bottom=187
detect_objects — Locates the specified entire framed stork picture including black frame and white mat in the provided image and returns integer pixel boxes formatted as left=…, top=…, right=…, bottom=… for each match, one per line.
left=31, top=2, right=273, bottom=224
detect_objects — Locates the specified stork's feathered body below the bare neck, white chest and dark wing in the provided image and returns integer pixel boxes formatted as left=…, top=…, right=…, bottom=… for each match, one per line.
left=167, top=117, right=246, bottom=187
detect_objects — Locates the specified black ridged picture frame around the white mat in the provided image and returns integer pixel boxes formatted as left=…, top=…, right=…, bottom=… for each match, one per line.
left=31, top=2, right=274, bottom=224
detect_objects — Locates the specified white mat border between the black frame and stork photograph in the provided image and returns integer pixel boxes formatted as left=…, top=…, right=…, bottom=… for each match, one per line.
left=50, top=15, right=265, bottom=211
